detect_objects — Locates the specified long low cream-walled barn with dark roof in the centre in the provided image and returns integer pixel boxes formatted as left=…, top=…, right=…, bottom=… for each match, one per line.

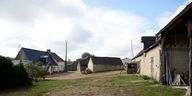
left=88, top=56, right=123, bottom=72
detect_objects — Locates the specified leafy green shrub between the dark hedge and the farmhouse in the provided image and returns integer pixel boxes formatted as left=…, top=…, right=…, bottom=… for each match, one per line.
left=25, top=63, right=47, bottom=81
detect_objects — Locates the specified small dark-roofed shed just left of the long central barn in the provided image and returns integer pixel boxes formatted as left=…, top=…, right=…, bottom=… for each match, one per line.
left=77, top=58, right=89, bottom=72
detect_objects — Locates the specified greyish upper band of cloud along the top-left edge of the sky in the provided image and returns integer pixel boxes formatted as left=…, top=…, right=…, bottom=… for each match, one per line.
left=0, top=0, right=86, bottom=24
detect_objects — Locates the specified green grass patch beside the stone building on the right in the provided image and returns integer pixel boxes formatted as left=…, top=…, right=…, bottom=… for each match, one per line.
left=111, top=75, right=186, bottom=96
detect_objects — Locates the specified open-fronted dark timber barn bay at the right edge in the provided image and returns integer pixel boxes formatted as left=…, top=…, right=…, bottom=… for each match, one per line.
left=156, top=3, right=192, bottom=85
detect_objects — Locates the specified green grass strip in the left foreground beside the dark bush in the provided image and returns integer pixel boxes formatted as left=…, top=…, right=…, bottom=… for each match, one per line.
left=0, top=80, right=71, bottom=96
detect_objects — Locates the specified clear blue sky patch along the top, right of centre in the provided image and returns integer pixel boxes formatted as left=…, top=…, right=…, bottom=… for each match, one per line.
left=84, top=0, right=185, bottom=20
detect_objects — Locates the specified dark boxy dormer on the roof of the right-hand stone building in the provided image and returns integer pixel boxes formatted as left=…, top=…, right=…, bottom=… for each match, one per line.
left=141, top=36, right=156, bottom=50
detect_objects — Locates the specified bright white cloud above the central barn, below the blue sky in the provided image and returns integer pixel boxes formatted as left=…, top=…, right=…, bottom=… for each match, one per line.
left=81, top=8, right=154, bottom=57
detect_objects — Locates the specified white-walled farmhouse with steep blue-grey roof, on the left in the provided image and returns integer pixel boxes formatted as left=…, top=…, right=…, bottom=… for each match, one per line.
left=13, top=48, right=65, bottom=73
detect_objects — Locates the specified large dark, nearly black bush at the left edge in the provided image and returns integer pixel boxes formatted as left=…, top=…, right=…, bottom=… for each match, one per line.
left=0, top=56, right=32, bottom=89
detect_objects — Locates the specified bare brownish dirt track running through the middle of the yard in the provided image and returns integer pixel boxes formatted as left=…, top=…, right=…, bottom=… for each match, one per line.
left=45, top=71, right=128, bottom=96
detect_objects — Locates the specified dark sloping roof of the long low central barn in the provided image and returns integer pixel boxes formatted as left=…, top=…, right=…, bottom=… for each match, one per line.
left=91, top=56, right=123, bottom=65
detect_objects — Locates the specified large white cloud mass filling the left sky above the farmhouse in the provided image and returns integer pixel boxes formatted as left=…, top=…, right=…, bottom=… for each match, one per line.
left=0, top=0, right=92, bottom=57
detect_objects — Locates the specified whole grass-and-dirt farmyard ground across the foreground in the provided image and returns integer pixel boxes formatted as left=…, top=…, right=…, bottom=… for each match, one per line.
left=0, top=73, right=186, bottom=96
